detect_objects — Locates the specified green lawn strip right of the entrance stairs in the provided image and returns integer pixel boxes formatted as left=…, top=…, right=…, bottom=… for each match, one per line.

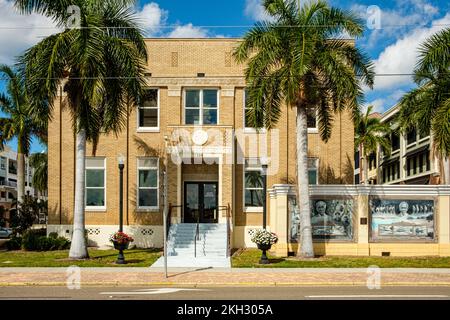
left=231, top=249, right=450, bottom=268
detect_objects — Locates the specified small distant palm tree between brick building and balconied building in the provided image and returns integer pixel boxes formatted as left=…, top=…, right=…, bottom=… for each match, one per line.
left=355, top=106, right=391, bottom=184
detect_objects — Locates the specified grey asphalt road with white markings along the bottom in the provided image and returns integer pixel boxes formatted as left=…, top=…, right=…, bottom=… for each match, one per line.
left=0, top=286, right=450, bottom=301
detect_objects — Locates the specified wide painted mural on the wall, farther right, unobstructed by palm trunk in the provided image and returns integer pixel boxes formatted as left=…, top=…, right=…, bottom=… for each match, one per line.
left=369, top=198, right=434, bottom=240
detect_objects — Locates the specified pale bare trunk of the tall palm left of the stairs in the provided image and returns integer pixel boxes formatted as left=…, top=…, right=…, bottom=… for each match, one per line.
left=69, top=129, right=89, bottom=259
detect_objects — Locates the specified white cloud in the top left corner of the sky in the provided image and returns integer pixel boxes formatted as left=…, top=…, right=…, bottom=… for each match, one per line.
left=0, top=0, right=58, bottom=64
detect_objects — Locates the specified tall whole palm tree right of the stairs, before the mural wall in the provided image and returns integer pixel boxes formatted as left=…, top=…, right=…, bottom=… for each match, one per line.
left=234, top=0, right=374, bottom=258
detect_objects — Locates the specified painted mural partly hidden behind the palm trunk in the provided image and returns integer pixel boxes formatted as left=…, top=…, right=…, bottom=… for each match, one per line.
left=289, top=197, right=353, bottom=242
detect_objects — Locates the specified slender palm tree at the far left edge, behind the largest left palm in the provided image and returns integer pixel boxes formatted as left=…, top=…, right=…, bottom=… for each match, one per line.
left=0, top=65, right=47, bottom=203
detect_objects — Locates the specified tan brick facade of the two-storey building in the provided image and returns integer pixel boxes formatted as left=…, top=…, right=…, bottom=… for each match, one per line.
left=48, top=39, right=354, bottom=240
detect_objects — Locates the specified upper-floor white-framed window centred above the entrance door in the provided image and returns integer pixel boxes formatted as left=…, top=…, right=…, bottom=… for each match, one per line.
left=184, top=89, right=219, bottom=125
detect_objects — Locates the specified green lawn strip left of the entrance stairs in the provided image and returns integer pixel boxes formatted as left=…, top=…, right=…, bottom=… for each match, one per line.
left=0, top=249, right=161, bottom=267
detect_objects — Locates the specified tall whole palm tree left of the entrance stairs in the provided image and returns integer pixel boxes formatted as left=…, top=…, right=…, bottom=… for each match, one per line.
left=15, top=0, right=147, bottom=259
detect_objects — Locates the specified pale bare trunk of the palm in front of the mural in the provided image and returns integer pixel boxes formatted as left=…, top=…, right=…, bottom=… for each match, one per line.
left=297, top=105, right=314, bottom=258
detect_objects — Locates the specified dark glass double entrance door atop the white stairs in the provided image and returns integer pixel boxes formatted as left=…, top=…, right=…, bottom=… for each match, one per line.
left=184, top=182, right=218, bottom=223
